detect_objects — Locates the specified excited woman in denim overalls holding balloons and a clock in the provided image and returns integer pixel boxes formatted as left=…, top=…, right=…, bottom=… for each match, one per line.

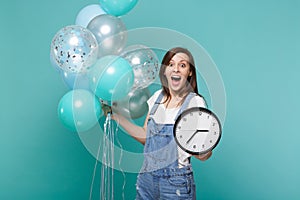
left=112, top=47, right=212, bottom=200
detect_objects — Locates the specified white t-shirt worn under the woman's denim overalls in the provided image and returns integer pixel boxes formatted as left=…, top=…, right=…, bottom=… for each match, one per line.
left=147, top=90, right=206, bottom=167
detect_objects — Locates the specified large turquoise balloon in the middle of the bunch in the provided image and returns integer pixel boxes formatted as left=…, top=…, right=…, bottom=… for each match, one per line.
left=89, top=55, right=134, bottom=102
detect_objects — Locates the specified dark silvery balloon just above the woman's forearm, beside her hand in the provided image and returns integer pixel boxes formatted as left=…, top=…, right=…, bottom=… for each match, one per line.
left=112, top=88, right=150, bottom=119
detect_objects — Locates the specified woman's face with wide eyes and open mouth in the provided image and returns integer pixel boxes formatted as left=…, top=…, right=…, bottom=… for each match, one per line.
left=164, top=53, right=192, bottom=94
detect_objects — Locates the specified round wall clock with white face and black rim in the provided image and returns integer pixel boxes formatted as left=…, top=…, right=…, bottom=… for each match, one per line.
left=174, top=107, right=222, bottom=154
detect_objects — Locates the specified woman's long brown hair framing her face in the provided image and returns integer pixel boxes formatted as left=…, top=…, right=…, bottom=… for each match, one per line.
left=159, top=47, right=201, bottom=105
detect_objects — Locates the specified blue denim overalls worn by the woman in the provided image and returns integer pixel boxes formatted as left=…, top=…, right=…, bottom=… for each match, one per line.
left=136, top=93, right=196, bottom=200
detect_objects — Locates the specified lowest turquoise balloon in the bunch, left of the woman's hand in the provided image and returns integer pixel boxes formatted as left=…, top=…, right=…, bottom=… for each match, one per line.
left=58, top=89, right=101, bottom=132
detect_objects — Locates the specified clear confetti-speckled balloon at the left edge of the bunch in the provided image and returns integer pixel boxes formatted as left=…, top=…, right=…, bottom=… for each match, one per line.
left=50, top=25, right=98, bottom=72
